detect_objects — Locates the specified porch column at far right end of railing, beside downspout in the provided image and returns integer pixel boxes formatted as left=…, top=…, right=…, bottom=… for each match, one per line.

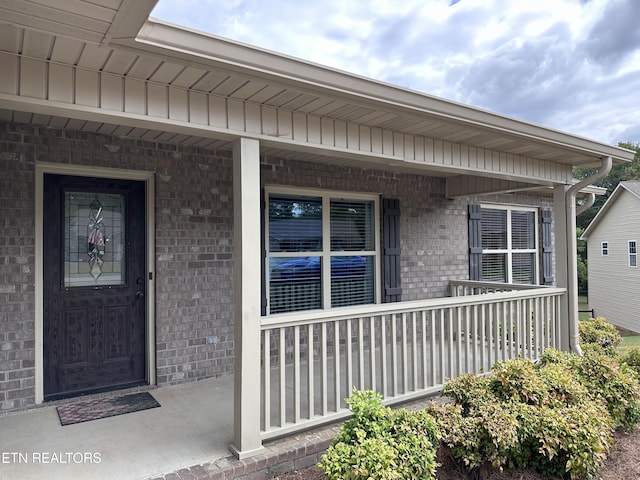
left=553, top=185, right=578, bottom=352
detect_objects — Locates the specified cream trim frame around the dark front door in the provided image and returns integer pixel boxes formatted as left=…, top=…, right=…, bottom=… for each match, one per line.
left=34, top=162, right=156, bottom=404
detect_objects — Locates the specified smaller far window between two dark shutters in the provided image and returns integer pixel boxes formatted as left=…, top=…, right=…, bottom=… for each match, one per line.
left=480, top=206, right=538, bottom=284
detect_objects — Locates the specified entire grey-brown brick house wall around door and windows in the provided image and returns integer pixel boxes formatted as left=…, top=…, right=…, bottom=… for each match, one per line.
left=0, top=123, right=552, bottom=413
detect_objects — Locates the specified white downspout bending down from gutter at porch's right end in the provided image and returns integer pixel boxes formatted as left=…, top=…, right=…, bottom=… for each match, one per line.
left=565, top=157, right=613, bottom=355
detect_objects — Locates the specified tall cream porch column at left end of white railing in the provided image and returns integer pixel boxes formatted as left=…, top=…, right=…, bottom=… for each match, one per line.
left=230, top=138, right=263, bottom=459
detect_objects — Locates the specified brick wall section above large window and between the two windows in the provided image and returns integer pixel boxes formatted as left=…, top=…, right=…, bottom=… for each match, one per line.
left=262, top=159, right=469, bottom=300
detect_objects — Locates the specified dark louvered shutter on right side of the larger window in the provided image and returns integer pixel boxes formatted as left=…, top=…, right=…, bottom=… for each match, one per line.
left=382, top=198, right=402, bottom=303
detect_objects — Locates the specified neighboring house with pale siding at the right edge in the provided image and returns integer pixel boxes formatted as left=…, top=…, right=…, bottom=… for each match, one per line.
left=582, top=180, right=640, bottom=332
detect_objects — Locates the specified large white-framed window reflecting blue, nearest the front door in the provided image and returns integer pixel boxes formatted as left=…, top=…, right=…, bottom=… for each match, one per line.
left=265, top=190, right=379, bottom=313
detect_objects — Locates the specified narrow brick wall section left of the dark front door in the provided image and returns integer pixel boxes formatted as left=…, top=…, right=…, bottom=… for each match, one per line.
left=0, top=124, right=35, bottom=412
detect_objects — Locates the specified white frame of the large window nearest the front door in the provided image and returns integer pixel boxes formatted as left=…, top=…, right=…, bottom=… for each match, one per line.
left=264, top=186, right=382, bottom=315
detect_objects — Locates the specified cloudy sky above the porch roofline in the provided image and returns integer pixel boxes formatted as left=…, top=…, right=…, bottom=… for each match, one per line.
left=151, top=0, right=640, bottom=145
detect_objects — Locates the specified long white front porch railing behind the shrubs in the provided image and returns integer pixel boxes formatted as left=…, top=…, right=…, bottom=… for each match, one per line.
left=256, top=282, right=565, bottom=439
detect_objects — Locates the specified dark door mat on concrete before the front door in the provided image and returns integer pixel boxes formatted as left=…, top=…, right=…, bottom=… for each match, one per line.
left=57, top=392, right=160, bottom=426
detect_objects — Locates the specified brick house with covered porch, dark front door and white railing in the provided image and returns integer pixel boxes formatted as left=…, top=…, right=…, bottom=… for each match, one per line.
left=0, top=0, right=633, bottom=457
